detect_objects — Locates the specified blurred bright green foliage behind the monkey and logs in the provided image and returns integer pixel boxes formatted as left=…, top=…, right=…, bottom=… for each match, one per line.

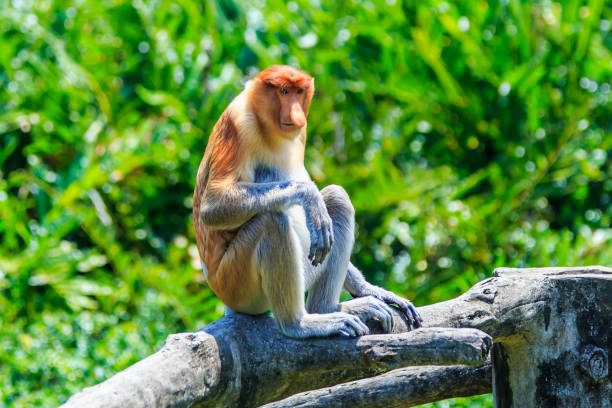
left=0, top=0, right=612, bottom=407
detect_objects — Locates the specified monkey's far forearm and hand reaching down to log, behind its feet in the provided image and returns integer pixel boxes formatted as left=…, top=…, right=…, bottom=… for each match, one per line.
left=344, top=263, right=423, bottom=328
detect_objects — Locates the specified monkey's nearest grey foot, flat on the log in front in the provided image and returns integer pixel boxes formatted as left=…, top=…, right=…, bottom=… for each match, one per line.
left=279, top=312, right=370, bottom=339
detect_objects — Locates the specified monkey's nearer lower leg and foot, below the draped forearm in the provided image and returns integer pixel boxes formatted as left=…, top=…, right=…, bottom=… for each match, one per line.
left=253, top=212, right=369, bottom=338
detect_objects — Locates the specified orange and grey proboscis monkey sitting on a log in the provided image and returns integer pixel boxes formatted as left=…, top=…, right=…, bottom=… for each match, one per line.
left=193, top=65, right=422, bottom=338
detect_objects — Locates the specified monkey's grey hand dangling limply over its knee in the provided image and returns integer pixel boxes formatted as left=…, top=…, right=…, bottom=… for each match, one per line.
left=303, top=183, right=334, bottom=266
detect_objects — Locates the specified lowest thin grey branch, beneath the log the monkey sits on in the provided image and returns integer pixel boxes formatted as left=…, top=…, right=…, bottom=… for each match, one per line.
left=262, top=363, right=491, bottom=408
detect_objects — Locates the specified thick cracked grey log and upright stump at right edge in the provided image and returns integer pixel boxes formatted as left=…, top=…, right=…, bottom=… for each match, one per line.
left=419, top=266, right=612, bottom=408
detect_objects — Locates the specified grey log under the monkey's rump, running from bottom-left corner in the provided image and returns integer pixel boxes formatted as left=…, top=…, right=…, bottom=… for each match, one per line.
left=65, top=324, right=491, bottom=408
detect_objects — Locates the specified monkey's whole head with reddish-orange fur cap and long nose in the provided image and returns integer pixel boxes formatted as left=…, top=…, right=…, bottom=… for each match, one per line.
left=250, top=65, right=314, bottom=139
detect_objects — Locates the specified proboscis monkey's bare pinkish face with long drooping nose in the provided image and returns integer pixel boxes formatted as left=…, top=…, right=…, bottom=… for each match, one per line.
left=274, top=87, right=308, bottom=139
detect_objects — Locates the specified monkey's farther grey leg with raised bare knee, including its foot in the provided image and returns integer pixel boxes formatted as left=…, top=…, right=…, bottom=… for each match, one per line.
left=304, top=185, right=393, bottom=331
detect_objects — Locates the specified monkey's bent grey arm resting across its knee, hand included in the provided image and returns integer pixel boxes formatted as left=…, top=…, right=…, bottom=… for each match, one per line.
left=199, top=181, right=333, bottom=265
